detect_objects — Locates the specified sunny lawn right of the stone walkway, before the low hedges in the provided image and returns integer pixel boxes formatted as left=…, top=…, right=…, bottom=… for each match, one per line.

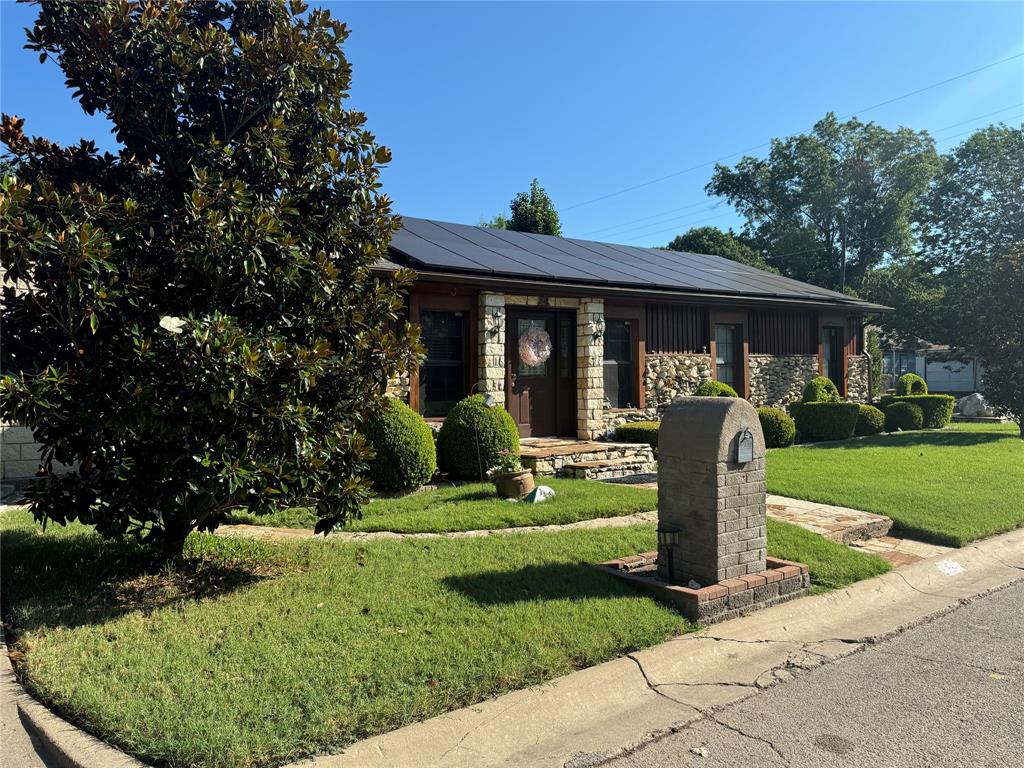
left=767, top=424, right=1024, bottom=547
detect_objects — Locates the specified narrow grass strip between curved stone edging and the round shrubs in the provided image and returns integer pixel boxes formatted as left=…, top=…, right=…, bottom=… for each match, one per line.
left=231, top=477, right=657, bottom=534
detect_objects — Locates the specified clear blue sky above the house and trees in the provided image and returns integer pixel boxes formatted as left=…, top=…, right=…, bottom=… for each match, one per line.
left=0, top=0, right=1024, bottom=245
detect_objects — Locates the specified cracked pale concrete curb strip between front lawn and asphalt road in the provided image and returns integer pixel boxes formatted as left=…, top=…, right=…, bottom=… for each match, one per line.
left=295, top=530, right=1024, bottom=768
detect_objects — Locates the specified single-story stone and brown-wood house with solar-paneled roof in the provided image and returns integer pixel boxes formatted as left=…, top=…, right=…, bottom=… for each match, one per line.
left=379, top=217, right=887, bottom=439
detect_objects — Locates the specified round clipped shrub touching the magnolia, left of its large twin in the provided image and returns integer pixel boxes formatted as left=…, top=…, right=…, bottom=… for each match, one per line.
left=361, top=397, right=437, bottom=490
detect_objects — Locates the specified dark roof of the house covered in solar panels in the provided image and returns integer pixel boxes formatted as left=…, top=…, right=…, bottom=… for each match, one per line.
left=391, top=216, right=886, bottom=311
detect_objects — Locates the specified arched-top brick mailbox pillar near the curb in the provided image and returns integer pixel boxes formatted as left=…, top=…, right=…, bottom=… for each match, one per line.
left=657, top=397, right=767, bottom=587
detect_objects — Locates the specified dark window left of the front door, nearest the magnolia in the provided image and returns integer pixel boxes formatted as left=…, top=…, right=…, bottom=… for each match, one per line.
left=420, top=309, right=466, bottom=418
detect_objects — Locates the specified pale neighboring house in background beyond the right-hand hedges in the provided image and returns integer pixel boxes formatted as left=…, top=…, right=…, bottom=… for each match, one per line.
left=882, top=340, right=984, bottom=394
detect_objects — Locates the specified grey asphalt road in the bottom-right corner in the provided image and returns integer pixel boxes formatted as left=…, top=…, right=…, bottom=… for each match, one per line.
left=605, top=584, right=1024, bottom=768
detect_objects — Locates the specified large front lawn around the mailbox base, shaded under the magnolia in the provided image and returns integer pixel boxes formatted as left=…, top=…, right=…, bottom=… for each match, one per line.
left=0, top=507, right=888, bottom=768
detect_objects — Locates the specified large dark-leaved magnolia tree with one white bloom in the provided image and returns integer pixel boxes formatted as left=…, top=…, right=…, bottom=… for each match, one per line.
left=0, top=0, right=420, bottom=558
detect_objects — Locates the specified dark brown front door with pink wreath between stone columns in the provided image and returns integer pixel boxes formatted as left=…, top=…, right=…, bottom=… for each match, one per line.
left=505, top=309, right=577, bottom=437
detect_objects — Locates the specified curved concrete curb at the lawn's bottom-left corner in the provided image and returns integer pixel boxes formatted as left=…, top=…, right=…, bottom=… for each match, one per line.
left=0, top=632, right=148, bottom=768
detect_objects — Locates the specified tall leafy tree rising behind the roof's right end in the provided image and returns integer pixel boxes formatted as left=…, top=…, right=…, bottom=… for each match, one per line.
left=707, top=113, right=938, bottom=291
